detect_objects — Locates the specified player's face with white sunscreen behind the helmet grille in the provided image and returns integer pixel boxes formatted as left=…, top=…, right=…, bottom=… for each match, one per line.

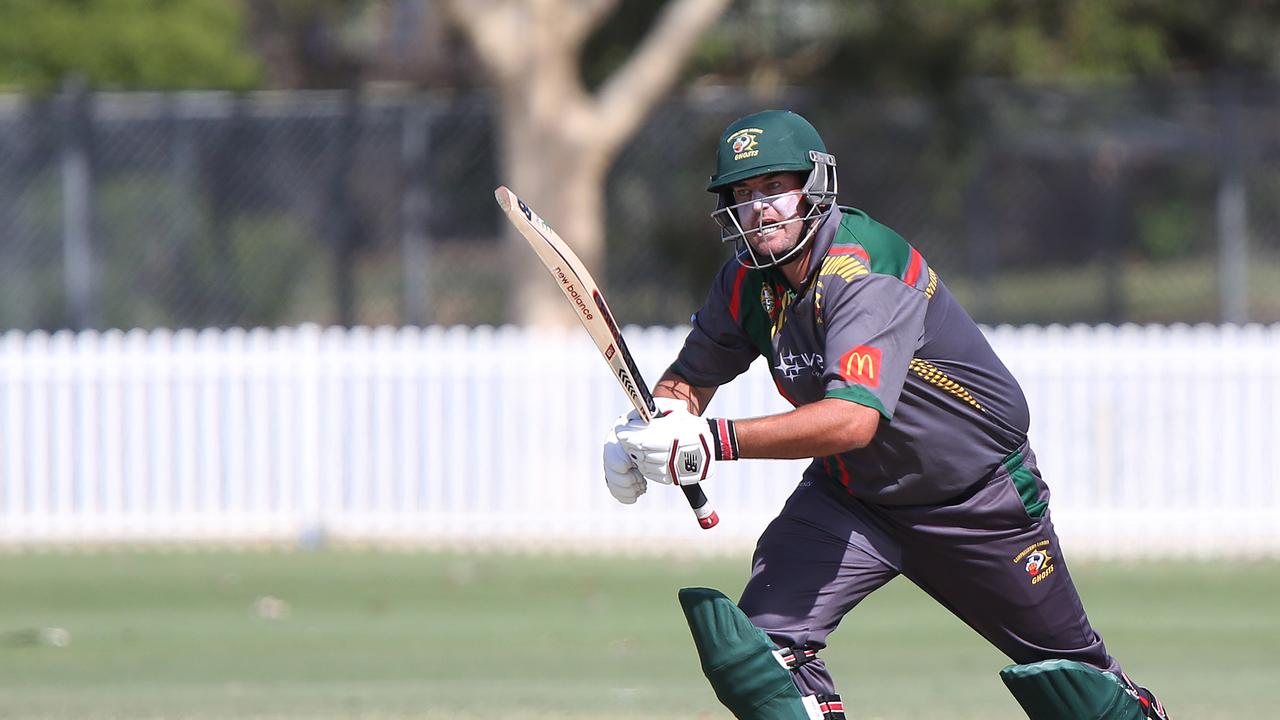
left=730, top=173, right=806, bottom=259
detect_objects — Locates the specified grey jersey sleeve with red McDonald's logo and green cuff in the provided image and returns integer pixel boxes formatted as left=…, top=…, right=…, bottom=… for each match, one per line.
left=818, top=273, right=928, bottom=420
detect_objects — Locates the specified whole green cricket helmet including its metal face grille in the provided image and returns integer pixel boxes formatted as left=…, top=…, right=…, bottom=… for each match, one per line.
left=707, top=110, right=837, bottom=268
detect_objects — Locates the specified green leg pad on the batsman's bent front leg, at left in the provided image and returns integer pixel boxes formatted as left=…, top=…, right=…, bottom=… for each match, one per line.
left=680, top=588, right=809, bottom=720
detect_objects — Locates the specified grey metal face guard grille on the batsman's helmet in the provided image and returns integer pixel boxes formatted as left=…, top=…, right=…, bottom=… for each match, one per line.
left=712, top=150, right=837, bottom=269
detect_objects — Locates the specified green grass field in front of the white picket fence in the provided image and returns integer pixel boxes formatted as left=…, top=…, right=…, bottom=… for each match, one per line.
left=0, top=551, right=1280, bottom=720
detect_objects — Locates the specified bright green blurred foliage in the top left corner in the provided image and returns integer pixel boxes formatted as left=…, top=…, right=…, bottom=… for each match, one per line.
left=0, top=0, right=261, bottom=92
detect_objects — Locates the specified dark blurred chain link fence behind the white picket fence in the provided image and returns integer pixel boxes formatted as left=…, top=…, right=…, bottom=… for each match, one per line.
left=0, top=78, right=1280, bottom=329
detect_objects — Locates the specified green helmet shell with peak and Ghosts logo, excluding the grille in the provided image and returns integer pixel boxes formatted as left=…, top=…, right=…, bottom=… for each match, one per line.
left=707, top=110, right=836, bottom=192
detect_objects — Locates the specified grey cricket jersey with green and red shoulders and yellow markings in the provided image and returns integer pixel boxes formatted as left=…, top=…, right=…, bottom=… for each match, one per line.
left=672, top=208, right=1029, bottom=505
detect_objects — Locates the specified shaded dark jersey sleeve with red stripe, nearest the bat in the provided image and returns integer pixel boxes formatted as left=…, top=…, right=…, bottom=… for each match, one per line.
left=671, top=263, right=760, bottom=387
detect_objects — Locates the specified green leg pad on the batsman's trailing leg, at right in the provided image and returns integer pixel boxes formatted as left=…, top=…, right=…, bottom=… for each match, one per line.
left=1000, top=660, right=1144, bottom=720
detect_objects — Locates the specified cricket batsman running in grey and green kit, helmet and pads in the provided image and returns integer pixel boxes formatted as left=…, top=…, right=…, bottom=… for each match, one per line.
left=604, top=110, right=1169, bottom=720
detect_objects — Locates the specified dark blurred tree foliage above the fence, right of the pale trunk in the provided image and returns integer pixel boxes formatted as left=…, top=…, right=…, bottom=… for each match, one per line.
left=698, top=0, right=1280, bottom=94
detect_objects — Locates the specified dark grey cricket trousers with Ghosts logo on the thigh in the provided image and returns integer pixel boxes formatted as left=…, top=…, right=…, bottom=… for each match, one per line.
left=739, top=447, right=1120, bottom=694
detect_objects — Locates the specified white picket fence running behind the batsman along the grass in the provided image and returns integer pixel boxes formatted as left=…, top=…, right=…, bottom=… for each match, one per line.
left=0, top=325, right=1280, bottom=557
